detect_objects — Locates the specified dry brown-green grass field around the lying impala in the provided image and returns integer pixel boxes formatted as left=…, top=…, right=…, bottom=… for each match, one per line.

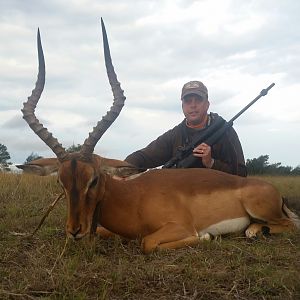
left=0, top=173, right=300, bottom=299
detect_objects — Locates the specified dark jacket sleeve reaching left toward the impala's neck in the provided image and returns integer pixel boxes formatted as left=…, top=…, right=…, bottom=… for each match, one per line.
left=125, top=126, right=177, bottom=169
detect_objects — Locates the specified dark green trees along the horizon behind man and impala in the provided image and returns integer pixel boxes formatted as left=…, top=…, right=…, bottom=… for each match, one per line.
left=0, top=143, right=300, bottom=175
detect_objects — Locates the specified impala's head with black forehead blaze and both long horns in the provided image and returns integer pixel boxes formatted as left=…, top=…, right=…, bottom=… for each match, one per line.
left=22, top=19, right=125, bottom=239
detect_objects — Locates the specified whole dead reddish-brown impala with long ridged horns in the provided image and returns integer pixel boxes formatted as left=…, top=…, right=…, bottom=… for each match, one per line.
left=22, top=19, right=300, bottom=253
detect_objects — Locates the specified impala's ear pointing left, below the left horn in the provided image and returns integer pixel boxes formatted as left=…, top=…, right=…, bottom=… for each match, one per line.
left=16, top=158, right=59, bottom=176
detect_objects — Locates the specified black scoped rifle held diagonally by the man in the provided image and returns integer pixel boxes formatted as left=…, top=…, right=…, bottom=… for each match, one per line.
left=162, top=83, right=275, bottom=169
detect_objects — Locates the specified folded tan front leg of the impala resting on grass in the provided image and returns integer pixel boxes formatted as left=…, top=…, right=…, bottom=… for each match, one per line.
left=141, top=222, right=204, bottom=254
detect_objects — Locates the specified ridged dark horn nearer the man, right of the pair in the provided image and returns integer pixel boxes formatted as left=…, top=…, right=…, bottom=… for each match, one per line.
left=81, top=18, right=126, bottom=156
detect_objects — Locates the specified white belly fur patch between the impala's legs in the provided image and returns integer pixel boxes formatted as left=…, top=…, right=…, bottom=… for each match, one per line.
left=199, top=217, right=250, bottom=235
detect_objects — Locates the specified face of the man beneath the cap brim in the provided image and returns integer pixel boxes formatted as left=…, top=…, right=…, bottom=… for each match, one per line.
left=182, top=94, right=209, bottom=126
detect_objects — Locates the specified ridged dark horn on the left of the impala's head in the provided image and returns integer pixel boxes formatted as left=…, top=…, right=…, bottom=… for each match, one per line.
left=21, top=29, right=68, bottom=161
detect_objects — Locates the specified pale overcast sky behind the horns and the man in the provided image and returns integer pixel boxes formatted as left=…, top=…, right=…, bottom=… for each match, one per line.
left=0, top=0, right=300, bottom=167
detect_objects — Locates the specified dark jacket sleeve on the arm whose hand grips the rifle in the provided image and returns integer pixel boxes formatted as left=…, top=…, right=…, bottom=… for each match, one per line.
left=212, top=128, right=247, bottom=177
